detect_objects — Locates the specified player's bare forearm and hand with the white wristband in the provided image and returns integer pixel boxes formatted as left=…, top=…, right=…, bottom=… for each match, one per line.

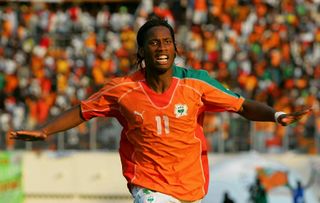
left=238, top=100, right=311, bottom=126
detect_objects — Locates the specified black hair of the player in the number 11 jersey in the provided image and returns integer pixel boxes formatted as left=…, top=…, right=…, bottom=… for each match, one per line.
left=137, top=15, right=177, bottom=66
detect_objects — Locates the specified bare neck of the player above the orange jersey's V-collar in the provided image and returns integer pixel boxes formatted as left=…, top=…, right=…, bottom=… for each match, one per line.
left=146, top=69, right=172, bottom=93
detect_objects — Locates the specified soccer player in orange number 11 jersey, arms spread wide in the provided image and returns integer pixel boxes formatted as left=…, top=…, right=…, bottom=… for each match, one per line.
left=10, top=19, right=310, bottom=203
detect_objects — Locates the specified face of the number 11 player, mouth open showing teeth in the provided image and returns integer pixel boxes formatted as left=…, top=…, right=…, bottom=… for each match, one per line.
left=142, top=26, right=175, bottom=73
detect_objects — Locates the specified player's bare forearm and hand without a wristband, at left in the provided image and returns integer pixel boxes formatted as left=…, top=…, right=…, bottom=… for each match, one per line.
left=10, top=105, right=84, bottom=141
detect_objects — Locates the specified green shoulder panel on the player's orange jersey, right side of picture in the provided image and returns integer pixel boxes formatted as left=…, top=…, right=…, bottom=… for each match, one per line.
left=173, top=65, right=240, bottom=98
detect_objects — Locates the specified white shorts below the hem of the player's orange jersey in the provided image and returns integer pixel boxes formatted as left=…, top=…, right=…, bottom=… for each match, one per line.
left=132, top=186, right=201, bottom=203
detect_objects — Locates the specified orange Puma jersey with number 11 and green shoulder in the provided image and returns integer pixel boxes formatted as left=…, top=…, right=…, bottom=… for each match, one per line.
left=81, top=66, right=244, bottom=201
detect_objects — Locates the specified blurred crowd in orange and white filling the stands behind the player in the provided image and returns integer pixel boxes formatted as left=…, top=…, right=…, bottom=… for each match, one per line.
left=0, top=0, right=320, bottom=153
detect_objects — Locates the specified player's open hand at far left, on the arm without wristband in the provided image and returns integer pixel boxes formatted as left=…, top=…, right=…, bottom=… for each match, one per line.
left=9, top=130, right=48, bottom=141
